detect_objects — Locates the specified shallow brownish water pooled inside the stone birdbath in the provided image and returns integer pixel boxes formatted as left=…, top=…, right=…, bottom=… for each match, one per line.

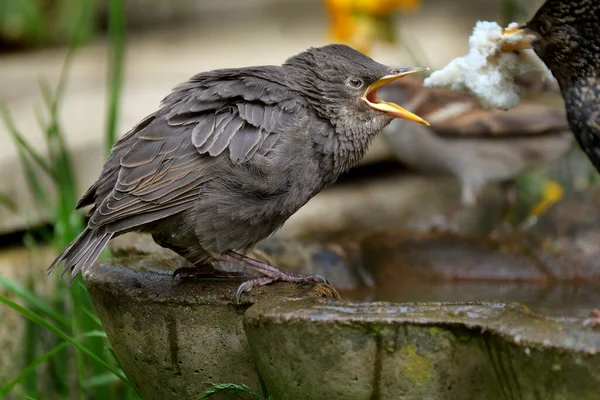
left=332, top=225, right=600, bottom=318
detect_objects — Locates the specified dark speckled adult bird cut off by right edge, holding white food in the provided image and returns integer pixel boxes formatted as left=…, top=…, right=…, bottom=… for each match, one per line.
left=508, top=0, right=600, bottom=172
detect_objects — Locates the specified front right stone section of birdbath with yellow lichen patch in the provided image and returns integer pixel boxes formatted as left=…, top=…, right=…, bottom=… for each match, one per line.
left=244, top=300, right=600, bottom=400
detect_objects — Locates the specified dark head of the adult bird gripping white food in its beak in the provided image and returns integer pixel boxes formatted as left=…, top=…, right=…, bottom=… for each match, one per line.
left=504, top=0, right=600, bottom=86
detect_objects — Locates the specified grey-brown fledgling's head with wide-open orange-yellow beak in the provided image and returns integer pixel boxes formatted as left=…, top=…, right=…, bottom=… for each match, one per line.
left=284, top=45, right=428, bottom=129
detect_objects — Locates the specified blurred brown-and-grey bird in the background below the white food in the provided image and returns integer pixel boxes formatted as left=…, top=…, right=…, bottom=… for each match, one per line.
left=381, top=77, right=572, bottom=206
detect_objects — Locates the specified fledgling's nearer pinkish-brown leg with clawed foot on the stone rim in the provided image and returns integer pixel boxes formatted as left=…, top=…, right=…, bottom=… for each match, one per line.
left=215, top=251, right=327, bottom=303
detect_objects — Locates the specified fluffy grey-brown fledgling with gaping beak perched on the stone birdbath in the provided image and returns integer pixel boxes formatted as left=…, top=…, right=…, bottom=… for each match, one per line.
left=49, top=45, right=427, bottom=301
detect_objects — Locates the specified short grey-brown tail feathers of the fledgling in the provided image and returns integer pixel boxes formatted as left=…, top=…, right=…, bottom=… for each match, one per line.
left=47, top=228, right=113, bottom=285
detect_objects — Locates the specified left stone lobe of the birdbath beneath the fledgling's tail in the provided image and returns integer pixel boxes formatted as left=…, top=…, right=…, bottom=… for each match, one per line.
left=84, top=255, right=336, bottom=400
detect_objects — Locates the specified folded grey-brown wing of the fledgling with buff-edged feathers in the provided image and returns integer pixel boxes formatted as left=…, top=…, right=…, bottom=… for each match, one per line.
left=76, top=67, right=306, bottom=234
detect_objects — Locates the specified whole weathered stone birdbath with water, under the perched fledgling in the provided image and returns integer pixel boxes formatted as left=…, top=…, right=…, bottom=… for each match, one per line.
left=84, top=186, right=600, bottom=400
